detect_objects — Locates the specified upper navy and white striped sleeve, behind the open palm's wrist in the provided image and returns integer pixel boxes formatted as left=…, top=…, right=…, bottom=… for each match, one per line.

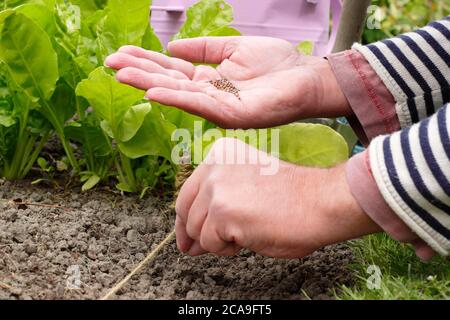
left=354, top=16, right=450, bottom=128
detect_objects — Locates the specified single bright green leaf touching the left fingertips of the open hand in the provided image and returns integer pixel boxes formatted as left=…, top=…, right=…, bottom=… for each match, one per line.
left=76, top=68, right=144, bottom=141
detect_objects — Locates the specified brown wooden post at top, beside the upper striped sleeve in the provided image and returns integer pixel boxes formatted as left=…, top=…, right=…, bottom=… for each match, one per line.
left=333, top=0, right=371, bottom=52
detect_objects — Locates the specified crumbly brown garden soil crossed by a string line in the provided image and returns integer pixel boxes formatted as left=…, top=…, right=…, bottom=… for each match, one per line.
left=0, top=180, right=352, bottom=300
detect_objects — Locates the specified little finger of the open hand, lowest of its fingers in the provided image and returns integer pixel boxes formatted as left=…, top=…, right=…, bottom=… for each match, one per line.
left=146, top=88, right=223, bottom=124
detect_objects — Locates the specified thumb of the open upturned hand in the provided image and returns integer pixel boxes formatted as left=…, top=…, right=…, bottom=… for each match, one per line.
left=167, top=37, right=239, bottom=64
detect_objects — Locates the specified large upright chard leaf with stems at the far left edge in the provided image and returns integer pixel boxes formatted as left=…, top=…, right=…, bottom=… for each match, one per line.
left=0, top=10, right=78, bottom=175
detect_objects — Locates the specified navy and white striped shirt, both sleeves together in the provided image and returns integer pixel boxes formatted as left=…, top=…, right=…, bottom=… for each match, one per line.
left=354, top=17, right=450, bottom=255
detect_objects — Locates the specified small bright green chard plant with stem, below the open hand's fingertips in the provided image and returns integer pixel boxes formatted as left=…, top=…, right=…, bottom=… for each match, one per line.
left=76, top=68, right=176, bottom=192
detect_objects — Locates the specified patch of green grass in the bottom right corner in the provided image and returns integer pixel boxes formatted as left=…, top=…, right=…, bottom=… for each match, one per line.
left=334, top=234, right=450, bottom=300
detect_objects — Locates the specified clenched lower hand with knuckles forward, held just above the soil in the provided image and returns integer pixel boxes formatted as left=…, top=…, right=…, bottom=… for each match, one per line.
left=172, top=139, right=381, bottom=258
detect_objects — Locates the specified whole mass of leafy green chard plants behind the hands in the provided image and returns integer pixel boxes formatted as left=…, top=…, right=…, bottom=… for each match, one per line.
left=0, top=0, right=348, bottom=194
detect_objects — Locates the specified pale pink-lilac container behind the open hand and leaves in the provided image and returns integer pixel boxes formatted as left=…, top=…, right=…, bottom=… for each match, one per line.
left=151, top=0, right=341, bottom=55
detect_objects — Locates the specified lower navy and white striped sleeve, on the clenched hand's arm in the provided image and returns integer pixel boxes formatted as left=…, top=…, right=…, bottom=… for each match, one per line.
left=369, top=104, right=450, bottom=255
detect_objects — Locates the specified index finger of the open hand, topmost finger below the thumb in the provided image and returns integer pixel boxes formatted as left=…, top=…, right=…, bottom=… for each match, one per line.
left=119, top=46, right=195, bottom=78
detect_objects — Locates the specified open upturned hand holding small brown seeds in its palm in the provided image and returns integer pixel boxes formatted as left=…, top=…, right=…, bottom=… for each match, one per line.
left=105, top=37, right=351, bottom=129
